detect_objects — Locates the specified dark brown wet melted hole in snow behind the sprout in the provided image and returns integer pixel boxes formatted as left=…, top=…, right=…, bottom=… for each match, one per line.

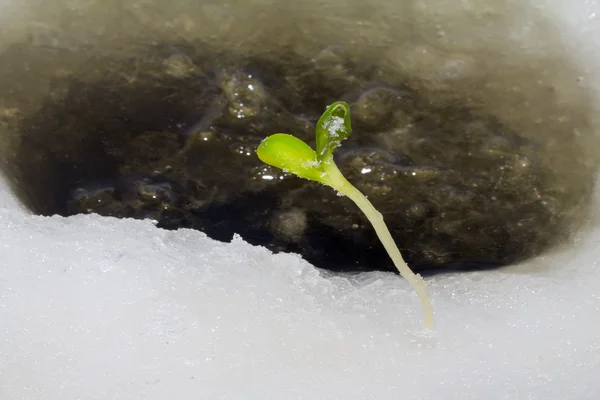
left=0, top=14, right=595, bottom=276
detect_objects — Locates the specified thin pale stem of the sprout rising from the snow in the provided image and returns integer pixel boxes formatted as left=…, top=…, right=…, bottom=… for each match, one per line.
left=323, top=160, right=433, bottom=329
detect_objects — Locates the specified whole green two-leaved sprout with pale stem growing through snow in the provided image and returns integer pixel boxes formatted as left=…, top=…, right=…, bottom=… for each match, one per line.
left=257, top=101, right=433, bottom=329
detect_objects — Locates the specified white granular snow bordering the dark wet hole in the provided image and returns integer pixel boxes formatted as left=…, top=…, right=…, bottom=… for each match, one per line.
left=0, top=0, right=600, bottom=400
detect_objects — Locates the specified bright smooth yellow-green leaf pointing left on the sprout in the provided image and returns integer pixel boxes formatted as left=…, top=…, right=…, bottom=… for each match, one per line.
left=256, top=133, right=323, bottom=182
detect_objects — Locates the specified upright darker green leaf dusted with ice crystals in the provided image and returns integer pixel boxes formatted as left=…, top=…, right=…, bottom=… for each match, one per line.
left=316, top=101, right=352, bottom=162
